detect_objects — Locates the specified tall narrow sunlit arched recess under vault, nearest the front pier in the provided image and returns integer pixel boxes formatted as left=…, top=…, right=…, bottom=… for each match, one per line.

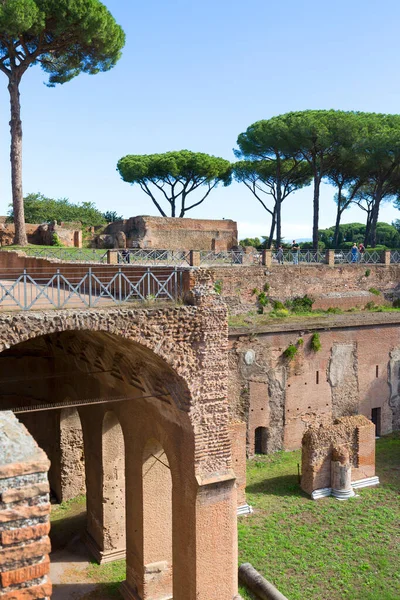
left=143, top=439, right=173, bottom=600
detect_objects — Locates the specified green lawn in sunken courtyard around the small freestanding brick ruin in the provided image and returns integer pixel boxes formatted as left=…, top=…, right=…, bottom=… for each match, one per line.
left=239, top=434, right=400, bottom=600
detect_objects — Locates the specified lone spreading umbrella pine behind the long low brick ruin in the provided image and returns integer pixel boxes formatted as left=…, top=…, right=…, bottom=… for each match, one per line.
left=117, top=150, right=232, bottom=217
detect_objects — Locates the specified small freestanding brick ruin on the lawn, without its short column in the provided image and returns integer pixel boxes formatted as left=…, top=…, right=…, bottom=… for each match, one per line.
left=301, top=415, right=375, bottom=494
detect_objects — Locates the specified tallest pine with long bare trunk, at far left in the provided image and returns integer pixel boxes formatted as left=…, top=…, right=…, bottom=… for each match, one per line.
left=0, top=0, right=125, bottom=245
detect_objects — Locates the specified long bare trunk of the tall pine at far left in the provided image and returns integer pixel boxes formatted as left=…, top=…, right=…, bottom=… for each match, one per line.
left=8, top=77, right=28, bottom=246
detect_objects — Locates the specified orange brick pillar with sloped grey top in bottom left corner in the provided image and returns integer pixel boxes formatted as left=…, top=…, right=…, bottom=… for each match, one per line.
left=0, top=411, right=52, bottom=600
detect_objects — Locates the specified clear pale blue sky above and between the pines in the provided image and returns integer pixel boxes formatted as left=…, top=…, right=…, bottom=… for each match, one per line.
left=0, top=0, right=400, bottom=238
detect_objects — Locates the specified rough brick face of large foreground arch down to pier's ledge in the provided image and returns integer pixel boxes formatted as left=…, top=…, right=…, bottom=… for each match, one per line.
left=0, top=305, right=231, bottom=474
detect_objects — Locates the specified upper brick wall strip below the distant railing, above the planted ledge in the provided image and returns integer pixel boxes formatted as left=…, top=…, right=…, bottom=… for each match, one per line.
left=210, top=264, right=400, bottom=314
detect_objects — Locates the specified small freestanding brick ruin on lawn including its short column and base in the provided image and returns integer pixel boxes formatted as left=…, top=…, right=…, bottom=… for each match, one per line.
left=301, top=415, right=379, bottom=497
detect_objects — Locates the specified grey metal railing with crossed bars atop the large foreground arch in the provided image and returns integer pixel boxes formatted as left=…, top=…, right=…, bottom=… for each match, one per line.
left=0, top=268, right=183, bottom=310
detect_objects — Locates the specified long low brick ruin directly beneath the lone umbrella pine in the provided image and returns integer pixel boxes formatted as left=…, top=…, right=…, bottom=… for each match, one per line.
left=94, top=216, right=238, bottom=252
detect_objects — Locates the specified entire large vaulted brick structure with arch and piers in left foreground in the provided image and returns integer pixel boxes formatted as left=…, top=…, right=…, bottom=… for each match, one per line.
left=0, top=283, right=237, bottom=600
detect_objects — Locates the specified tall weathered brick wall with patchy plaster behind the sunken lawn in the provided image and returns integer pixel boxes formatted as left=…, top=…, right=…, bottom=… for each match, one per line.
left=229, top=313, right=400, bottom=456
